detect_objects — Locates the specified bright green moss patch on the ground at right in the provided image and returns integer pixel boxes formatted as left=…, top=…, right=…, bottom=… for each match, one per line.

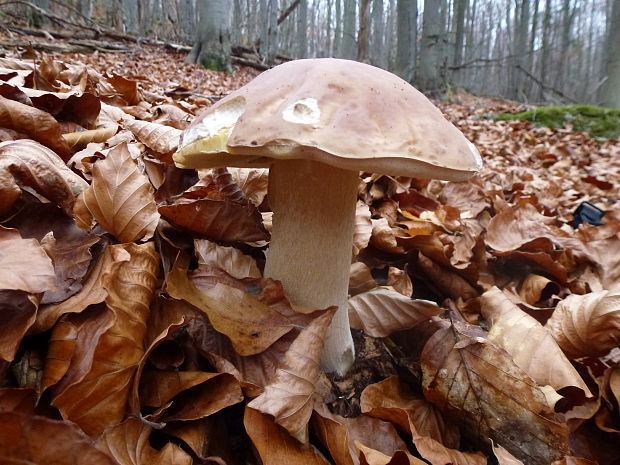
left=493, top=105, right=620, bottom=139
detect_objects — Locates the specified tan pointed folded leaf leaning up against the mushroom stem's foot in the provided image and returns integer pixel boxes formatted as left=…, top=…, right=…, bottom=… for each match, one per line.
left=248, top=308, right=336, bottom=443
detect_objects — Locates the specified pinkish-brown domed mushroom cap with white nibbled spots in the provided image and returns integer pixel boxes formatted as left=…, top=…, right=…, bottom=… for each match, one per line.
left=174, top=58, right=482, bottom=181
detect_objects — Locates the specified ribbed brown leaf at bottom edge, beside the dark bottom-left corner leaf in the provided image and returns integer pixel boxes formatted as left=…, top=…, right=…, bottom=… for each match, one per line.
left=97, top=418, right=192, bottom=465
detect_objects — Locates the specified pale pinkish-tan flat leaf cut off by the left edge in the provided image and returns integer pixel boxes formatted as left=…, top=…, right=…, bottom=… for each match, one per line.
left=0, top=227, right=56, bottom=294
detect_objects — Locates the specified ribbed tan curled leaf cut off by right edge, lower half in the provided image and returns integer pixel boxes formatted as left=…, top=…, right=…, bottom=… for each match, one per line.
left=546, top=291, right=620, bottom=359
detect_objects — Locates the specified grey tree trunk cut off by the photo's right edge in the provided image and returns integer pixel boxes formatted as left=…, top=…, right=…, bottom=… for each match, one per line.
left=600, top=1, right=620, bottom=108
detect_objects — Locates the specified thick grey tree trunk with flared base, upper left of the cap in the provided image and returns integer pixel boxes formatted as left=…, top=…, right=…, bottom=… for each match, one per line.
left=187, top=0, right=233, bottom=71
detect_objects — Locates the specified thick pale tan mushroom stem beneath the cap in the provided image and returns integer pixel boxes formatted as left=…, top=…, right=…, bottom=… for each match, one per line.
left=265, top=160, right=359, bottom=375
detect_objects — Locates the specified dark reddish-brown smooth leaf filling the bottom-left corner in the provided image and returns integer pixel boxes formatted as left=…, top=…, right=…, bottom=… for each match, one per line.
left=0, top=412, right=118, bottom=465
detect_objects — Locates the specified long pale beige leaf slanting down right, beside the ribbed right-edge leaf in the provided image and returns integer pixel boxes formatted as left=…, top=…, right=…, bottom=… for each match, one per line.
left=480, top=288, right=592, bottom=397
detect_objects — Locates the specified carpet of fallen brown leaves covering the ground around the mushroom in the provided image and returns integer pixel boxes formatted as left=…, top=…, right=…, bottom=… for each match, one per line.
left=0, top=40, right=620, bottom=465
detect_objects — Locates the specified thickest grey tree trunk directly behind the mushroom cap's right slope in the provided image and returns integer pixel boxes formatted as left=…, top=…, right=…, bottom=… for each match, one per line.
left=416, top=0, right=446, bottom=97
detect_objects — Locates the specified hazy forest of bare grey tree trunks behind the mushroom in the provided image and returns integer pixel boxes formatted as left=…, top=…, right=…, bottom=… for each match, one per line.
left=4, top=0, right=620, bottom=107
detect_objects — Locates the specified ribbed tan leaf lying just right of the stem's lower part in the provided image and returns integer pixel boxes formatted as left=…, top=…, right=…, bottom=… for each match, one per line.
left=349, top=287, right=443, bottom=337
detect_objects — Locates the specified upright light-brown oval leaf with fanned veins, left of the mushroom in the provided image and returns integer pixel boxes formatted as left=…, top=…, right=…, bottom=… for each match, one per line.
left=76, top=144, right=159, bottom=242
